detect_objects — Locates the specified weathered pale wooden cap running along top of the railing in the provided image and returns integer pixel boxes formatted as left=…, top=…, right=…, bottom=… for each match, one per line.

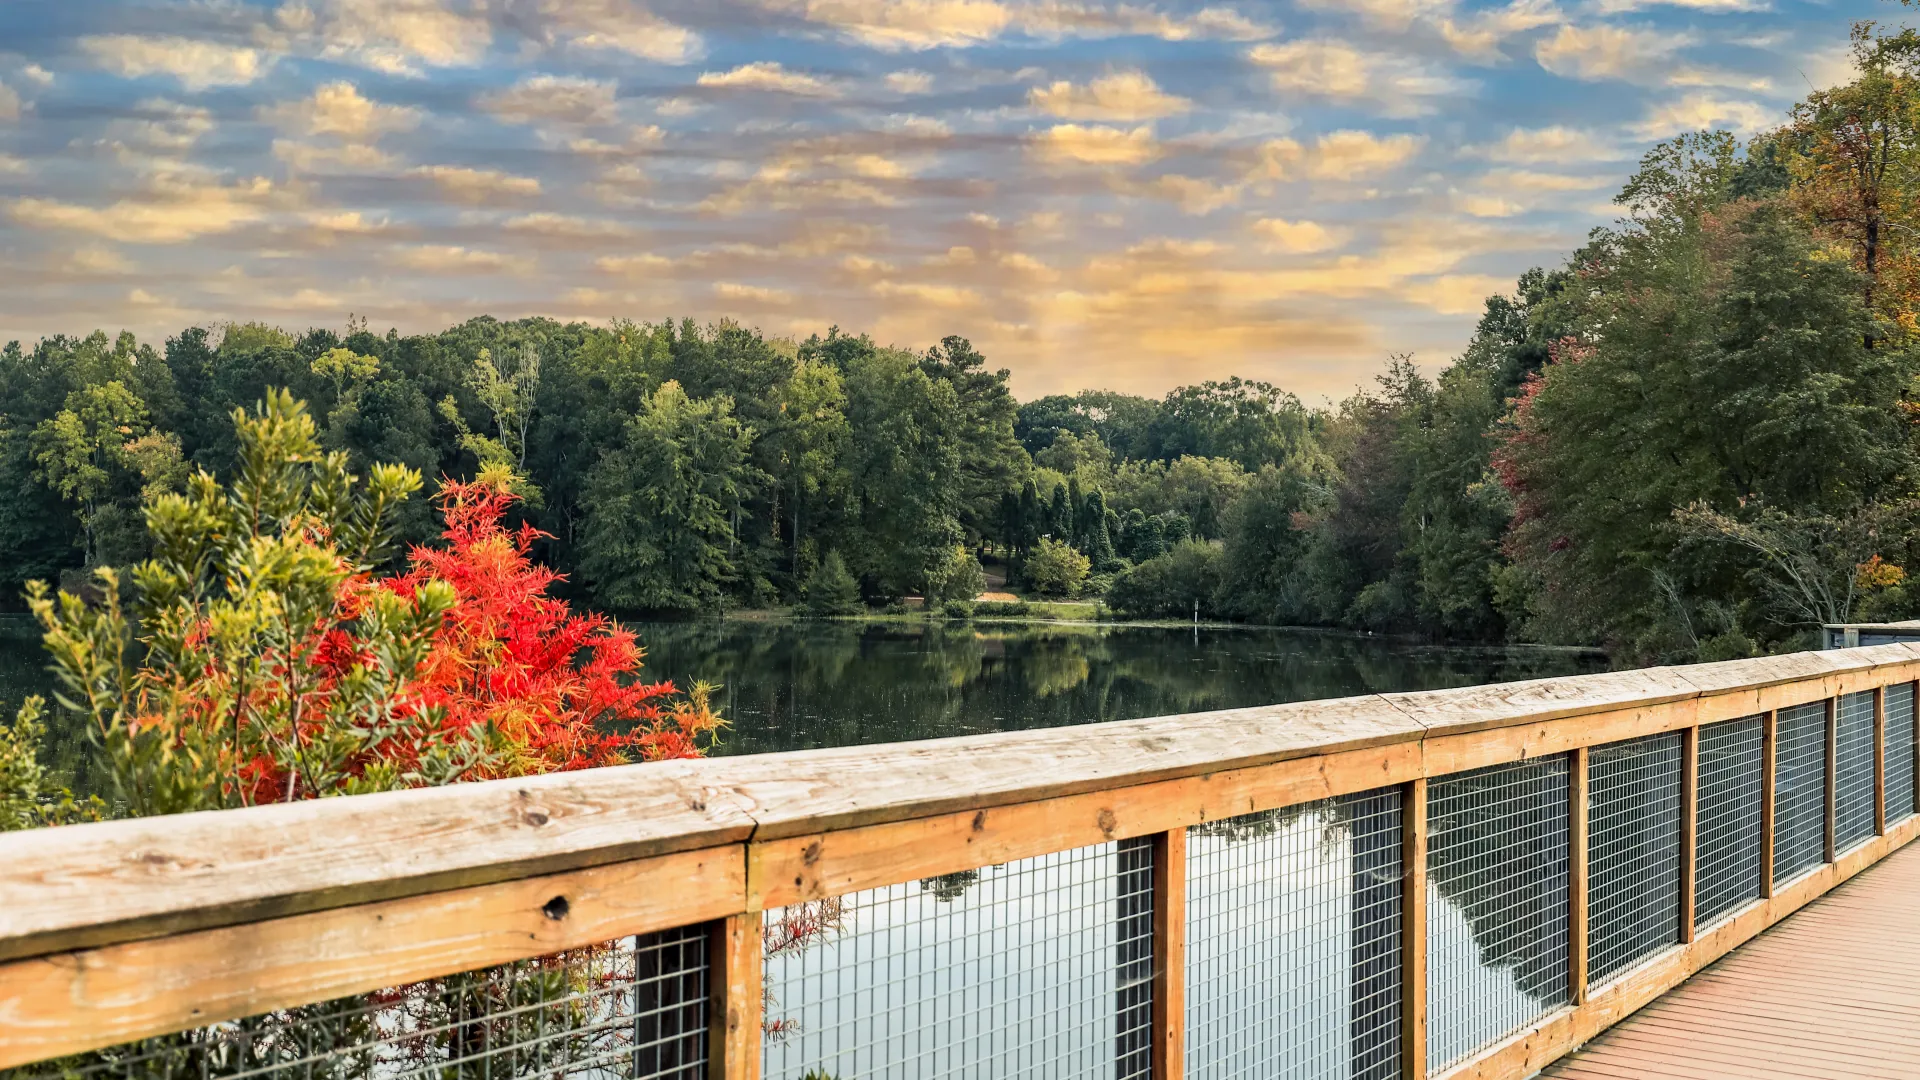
left=0, top=644, right=1920, bottom=959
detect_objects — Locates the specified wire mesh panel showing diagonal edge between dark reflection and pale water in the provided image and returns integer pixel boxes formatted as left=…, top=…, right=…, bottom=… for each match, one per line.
left=1427, top=757, right=1571, bottom=1072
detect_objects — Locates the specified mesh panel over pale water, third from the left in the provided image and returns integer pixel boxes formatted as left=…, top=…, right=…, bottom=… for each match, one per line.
left=1187, top=788, right=1402, bottom=1080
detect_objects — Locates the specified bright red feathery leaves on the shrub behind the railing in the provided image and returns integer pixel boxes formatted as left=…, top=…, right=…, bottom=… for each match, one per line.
left=382, top=472, right=720, bottom=774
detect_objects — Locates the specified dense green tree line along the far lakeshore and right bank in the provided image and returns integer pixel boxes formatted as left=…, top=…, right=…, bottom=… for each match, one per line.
left=11, top=25, right=1920, bottom=659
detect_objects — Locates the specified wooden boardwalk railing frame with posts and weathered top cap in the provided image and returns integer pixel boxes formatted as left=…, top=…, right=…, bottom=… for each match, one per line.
left=0, top=644, right=1920, bottom=1080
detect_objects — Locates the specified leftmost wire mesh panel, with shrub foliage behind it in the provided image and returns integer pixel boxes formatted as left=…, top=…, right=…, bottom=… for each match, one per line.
left=10, top=926, right=708, bottom=1080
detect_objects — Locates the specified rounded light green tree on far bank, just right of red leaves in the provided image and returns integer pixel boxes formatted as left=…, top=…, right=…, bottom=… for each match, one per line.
left=580, top=382, right=755, bottom=611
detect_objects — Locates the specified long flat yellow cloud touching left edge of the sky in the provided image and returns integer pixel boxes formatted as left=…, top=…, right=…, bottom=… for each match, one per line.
left=10, top=179, right=273, bottom=244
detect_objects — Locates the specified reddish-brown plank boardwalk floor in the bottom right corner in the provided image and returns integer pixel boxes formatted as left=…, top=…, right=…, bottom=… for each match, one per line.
left=1542, top=844, right=1920, bottom=1080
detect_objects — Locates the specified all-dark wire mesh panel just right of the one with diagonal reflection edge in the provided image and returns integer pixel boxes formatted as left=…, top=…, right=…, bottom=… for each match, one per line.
left=1586, top=732, right=1680, bottom=984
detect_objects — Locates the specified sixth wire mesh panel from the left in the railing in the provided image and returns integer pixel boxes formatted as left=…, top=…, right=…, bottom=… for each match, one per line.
left=1693, top=717, right=1766, bottom=928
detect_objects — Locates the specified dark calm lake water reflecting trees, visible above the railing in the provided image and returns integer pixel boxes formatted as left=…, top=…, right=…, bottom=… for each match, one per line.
left=0, top=615, right=1605, bottom=788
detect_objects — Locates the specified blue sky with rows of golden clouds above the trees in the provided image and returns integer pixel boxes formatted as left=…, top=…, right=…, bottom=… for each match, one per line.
left=0, top=0, right=1905, bottom=402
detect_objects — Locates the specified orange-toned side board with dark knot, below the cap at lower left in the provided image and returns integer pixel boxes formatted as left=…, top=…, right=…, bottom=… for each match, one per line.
left=0, top=847, right=741, bottom=1068
